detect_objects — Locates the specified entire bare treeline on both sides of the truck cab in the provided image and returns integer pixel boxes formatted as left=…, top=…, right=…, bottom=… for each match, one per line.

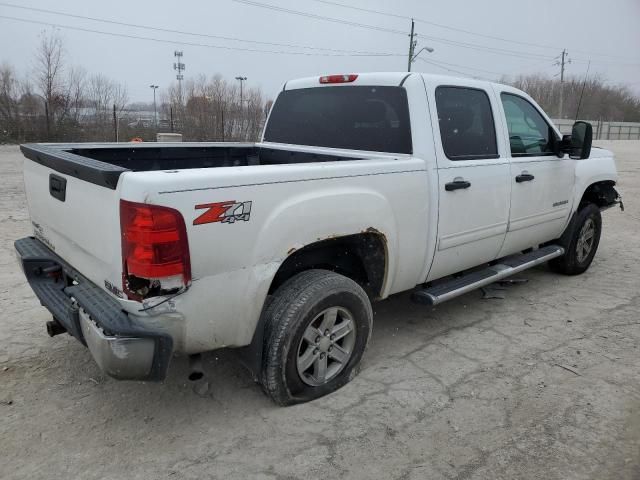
left=0, top=31, right=640, bottom=143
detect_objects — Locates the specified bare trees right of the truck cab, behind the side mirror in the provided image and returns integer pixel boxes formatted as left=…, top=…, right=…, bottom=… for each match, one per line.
left=503, top=75, right=640, bottom=122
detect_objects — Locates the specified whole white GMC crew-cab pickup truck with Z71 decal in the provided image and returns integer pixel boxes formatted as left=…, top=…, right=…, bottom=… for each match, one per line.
left=15, top=72, right=622, bottom=404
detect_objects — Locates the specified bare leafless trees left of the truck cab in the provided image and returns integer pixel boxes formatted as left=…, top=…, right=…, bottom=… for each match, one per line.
left=0, top=31, right=269, bottom=143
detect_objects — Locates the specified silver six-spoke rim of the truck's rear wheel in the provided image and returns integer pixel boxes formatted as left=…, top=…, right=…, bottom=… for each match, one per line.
left=296, top=307, right=356, bottom=387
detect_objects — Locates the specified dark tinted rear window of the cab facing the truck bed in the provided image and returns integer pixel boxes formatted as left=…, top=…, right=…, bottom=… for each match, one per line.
left=264, top=86, right=412, bottom=153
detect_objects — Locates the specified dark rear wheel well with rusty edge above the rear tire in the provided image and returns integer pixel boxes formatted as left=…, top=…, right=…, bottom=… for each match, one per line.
left=269, top=232, right=387, bottom=298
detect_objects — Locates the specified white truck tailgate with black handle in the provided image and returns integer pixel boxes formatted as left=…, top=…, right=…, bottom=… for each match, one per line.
left=23, top=155, right=122, bottom=296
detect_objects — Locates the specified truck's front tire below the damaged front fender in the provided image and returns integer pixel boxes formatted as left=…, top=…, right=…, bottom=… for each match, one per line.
left=549, top=203, right=602, bottom=275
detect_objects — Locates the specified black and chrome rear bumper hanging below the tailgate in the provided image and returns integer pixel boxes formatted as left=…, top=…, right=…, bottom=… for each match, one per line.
left=15, top=237, right=173, bottom=381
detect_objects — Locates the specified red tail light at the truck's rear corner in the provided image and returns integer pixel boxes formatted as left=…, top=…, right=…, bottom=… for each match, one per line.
left=120, top=200, right=191, bottom=298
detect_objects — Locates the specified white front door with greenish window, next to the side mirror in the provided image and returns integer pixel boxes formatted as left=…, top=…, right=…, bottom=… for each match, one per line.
left=496, top=88, right=575, bottom=256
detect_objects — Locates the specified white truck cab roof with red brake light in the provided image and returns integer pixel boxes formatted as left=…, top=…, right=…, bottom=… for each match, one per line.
left=282, top=72, right=496, bottom=90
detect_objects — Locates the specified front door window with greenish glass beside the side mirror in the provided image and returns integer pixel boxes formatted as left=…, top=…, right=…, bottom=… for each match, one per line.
left=500, top=93, right=555, bottom=157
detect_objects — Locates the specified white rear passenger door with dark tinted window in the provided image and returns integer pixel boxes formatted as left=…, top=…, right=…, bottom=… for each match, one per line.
left=425, top=79, right=510, bottom=280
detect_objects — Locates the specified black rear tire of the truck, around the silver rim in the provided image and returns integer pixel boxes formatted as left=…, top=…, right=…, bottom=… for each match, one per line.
left=261, top=270, right=373, bottom=405
